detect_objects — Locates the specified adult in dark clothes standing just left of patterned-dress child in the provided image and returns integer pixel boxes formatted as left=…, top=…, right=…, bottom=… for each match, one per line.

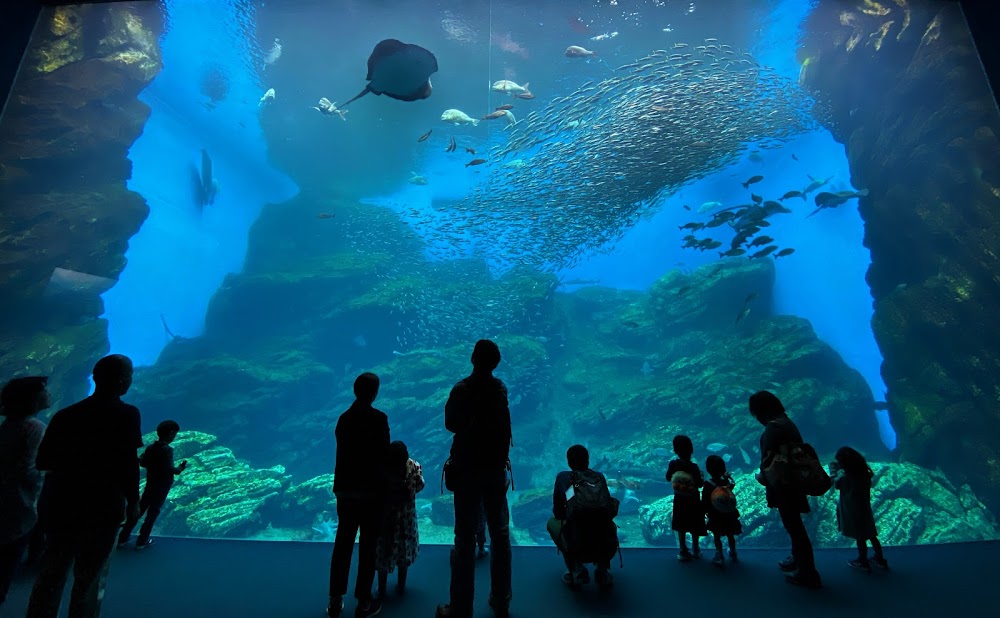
left=326, top=373, right=389, bottom=618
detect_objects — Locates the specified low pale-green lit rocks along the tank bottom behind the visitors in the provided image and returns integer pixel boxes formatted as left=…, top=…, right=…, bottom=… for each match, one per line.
left=152, top=431, right=1000, bottom=547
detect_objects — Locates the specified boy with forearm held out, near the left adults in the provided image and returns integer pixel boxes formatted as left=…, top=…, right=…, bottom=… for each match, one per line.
left=118, top=421, right=187, bottom=549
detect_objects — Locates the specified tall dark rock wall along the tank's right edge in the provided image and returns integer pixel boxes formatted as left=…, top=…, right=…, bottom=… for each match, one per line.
left=800, top=0, right=1000, bottom=511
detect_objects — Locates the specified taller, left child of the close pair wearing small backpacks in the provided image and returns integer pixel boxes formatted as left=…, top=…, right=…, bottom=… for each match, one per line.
left=667, top=436, right=708, bottom=562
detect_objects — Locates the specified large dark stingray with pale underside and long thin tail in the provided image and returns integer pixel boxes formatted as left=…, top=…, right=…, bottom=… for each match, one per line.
left=340, top=39, right=437, bottom=109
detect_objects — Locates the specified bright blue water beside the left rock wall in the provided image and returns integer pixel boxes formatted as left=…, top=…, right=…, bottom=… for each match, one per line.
left=104, top=0, right=298, bottom=366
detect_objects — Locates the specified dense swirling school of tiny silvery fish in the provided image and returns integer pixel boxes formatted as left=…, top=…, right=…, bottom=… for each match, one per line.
left=414, top=39, right=815, bottom=271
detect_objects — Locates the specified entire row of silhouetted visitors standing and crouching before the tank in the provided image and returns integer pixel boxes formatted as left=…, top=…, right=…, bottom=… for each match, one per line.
left=0, top=340, right=888, bottom=618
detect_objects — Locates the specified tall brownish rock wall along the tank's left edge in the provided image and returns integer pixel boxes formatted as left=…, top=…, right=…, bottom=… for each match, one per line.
left=0, top=3, right=162, bottom=408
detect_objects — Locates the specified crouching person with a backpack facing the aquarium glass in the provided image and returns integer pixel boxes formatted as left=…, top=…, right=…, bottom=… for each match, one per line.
left=546, top=444, right=618, bottom=587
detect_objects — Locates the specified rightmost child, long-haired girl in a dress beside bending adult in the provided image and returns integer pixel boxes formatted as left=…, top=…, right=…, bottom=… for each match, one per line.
left=830, top=446, right=889, bottom=571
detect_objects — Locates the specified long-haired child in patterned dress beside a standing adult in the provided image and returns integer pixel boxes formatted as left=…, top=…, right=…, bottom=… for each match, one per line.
left=375, top=440, right=424, bottom=599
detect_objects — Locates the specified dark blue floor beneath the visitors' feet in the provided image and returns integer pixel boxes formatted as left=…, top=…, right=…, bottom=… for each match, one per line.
left=0, top=539, right=1000, bottom=618
